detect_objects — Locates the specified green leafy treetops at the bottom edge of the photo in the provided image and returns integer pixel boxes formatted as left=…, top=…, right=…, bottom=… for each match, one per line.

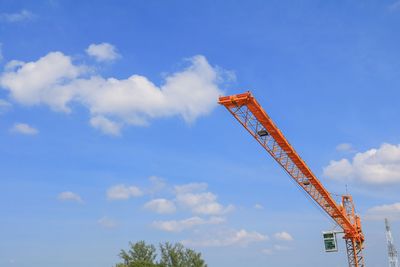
left=115, top=241, right=207, bottom=267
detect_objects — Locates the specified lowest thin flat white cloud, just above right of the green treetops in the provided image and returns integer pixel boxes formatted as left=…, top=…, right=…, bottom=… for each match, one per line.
left=182, top=229, right=268, bottom=247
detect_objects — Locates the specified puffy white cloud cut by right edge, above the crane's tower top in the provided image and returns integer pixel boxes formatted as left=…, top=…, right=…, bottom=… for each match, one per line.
left=324, top=144, right=400, bottom=184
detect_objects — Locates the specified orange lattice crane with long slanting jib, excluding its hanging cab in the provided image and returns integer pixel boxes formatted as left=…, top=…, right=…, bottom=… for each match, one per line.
left=218, top=92, right=365, bottom=267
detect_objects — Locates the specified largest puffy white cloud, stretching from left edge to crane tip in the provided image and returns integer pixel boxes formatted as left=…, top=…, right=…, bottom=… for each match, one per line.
left=0, top=49, right=227, bottom=134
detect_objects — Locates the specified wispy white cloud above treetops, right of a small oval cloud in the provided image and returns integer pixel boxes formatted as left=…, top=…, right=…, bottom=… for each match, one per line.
left=175, top=183, right=234, bottom=215
